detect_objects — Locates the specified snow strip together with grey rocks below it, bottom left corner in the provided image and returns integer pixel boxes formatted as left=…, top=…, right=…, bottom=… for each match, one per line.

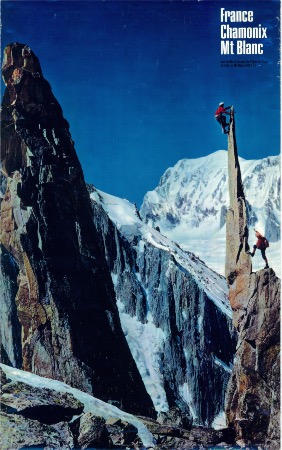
left=0, top=365, right=154, bottom=450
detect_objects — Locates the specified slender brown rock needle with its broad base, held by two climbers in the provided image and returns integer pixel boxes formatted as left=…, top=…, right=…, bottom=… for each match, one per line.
left=226, top=108, right=280, bottom=449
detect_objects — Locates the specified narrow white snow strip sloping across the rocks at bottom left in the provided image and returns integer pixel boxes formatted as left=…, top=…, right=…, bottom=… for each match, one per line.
left=0, top=364, right=155, bottom=448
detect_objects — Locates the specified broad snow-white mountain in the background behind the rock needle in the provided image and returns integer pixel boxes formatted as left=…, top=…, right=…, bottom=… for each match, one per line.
left=140, top=150, right=280, bottom=274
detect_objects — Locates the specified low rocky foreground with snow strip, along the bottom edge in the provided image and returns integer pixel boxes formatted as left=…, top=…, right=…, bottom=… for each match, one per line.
left=0, top=365, right=237, bottom=450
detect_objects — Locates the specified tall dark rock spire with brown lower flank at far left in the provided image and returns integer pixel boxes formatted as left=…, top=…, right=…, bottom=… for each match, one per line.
left=1, top=43, right=153, bottom=414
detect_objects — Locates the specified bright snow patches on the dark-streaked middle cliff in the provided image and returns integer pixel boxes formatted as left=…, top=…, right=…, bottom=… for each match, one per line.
left=91, top=185, right=232, bottom=419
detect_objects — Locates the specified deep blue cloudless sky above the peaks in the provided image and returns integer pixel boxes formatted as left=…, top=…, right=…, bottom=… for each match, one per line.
left=2, top=0, right=280, bottom=205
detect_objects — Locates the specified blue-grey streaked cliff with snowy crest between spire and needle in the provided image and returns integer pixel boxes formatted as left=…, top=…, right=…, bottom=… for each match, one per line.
left=91, top=188, right=236, bottom=426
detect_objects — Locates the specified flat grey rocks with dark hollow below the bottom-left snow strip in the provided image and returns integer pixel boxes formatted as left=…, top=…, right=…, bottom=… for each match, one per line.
left=0, top=369, right=79, bottom=449
